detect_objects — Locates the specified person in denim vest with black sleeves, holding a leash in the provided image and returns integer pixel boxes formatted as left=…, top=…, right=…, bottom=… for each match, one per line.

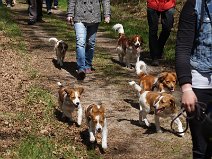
left=175, top=0, right=212, bottom=159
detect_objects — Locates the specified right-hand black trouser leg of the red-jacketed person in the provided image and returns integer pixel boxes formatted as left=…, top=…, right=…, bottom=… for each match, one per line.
left=158, top=8, right=175, bottom=58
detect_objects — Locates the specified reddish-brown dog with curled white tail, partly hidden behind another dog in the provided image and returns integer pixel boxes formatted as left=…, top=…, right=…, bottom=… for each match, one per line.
left=135, top=61, right=177, bottom=92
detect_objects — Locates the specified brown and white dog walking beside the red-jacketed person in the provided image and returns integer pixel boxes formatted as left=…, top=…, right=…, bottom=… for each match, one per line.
left=113, top=24, right=143, bottom=68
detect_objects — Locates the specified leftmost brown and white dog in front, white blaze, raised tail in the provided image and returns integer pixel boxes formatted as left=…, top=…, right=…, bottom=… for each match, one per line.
left=57, top=82, right=84, bottom=126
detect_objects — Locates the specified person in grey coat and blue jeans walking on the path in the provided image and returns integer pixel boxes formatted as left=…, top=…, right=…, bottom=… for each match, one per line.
left=67, top=0, right=111, bottom=80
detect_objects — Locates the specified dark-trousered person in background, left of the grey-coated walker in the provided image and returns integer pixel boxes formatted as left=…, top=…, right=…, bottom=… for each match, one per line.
left=28, top=0, right=43, bottom=25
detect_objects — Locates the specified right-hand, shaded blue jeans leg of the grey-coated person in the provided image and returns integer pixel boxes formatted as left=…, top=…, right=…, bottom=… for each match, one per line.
left=85, top=23, right=99, bottom=69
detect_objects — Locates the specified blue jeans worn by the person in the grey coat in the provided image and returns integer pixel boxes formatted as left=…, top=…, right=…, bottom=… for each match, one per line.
left=74, top=22, right=99, bottom=71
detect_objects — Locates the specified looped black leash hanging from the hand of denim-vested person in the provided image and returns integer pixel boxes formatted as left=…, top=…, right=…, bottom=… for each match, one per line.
left=170, top=102, right=207, bottom=134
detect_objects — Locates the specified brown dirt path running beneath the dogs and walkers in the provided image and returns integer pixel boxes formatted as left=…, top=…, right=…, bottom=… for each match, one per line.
left=1, top=1, right=191, bottom=159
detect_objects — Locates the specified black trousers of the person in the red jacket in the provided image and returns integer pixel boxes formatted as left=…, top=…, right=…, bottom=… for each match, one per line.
left=147, top=8, right=175, bottom=59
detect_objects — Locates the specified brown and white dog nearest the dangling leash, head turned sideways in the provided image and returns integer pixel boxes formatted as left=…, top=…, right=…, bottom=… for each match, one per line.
left=129, top=81, right=184, bottom=136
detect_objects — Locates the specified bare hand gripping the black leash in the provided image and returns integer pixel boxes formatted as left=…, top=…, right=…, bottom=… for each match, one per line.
left=181, top=84, right=197, bottom=112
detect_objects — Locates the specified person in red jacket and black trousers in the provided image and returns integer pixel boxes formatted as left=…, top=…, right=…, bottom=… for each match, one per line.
left=147, top=0, right=176, bottom=66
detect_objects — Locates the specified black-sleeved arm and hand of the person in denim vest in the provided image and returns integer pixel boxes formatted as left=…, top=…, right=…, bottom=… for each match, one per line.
left=175, top=0, right=197, bottom=112
